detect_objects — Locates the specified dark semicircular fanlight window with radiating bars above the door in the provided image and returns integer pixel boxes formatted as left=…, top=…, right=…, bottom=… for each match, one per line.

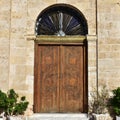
left=35, top=5, right=88, bottom=36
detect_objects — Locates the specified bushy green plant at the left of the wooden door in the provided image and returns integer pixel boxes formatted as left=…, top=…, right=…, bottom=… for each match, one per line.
left=0, top=89, right=29, bottom=120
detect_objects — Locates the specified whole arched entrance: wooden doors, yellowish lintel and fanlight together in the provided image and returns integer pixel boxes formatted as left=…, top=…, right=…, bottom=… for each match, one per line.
left=34, top=3, right=88, bottom=113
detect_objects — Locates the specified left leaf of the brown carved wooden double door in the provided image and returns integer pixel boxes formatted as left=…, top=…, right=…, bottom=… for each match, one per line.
left=38, top=46, right=59, bottom=112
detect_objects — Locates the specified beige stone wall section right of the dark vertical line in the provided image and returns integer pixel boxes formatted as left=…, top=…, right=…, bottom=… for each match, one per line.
left=98, top=0, right=120, bottom=90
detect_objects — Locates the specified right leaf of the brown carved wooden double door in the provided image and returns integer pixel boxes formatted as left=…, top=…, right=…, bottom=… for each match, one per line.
left=60, top=46, right=83, bottom=112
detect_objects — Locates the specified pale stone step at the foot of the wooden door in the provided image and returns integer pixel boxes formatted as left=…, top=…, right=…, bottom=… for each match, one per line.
left=26, top=113, right=89, bottom=120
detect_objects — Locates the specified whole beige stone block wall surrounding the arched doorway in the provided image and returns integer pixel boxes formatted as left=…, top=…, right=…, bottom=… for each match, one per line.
left=0, top=0, right=120, bottom=115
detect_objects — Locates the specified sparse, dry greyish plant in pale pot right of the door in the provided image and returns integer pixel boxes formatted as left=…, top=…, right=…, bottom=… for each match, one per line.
left=89, top=86, right=110, bottom=120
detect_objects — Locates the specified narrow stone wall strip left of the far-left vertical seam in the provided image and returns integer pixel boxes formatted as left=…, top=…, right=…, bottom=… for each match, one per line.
left=0, top=0, right=11, bottom=90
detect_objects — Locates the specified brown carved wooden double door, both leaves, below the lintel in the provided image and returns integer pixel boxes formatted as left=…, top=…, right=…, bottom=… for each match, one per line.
left=34, top=44, right=87, bottom=113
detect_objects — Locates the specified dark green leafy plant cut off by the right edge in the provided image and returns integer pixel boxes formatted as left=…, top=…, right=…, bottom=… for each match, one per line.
left=110, top=87, right=120, bottom=120
